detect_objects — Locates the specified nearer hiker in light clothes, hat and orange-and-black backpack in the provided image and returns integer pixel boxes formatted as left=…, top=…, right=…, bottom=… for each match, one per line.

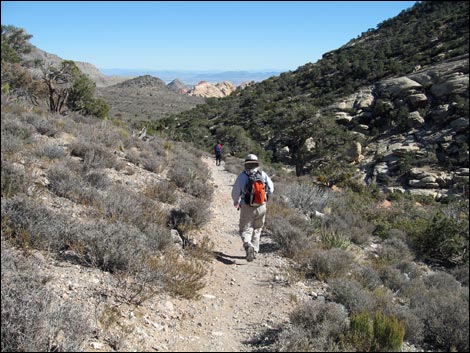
left=232, top=154, right=274, bottom=262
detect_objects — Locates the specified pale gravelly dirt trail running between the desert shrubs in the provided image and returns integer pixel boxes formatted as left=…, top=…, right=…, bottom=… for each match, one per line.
left=159, top=157, right=302, bottom=352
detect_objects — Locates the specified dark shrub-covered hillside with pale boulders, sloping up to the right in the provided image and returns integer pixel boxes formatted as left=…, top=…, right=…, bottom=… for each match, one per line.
left=159, top=1, right=469, bottom=198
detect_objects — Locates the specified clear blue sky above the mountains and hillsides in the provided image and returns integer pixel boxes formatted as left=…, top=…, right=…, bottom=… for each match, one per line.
left=1, top=1, right=415, bottom=71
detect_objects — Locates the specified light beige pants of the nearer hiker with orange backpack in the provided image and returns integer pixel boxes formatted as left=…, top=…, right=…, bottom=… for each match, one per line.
left=239, top=204, right=266, bottom=252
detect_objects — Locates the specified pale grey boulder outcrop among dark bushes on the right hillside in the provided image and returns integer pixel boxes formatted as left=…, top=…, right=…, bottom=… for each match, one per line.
left=322, top=55, right=469, bottom=198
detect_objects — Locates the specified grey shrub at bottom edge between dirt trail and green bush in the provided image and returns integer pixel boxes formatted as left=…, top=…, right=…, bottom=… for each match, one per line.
left=277, top=301, right=348, bottom=352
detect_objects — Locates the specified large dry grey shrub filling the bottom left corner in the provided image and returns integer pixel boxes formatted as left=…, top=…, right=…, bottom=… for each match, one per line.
left=1, top=241, right=92, bottom=352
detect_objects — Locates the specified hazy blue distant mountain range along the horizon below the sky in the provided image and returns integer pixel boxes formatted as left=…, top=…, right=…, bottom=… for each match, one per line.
left=101, top=69, right=281, bottom=86
